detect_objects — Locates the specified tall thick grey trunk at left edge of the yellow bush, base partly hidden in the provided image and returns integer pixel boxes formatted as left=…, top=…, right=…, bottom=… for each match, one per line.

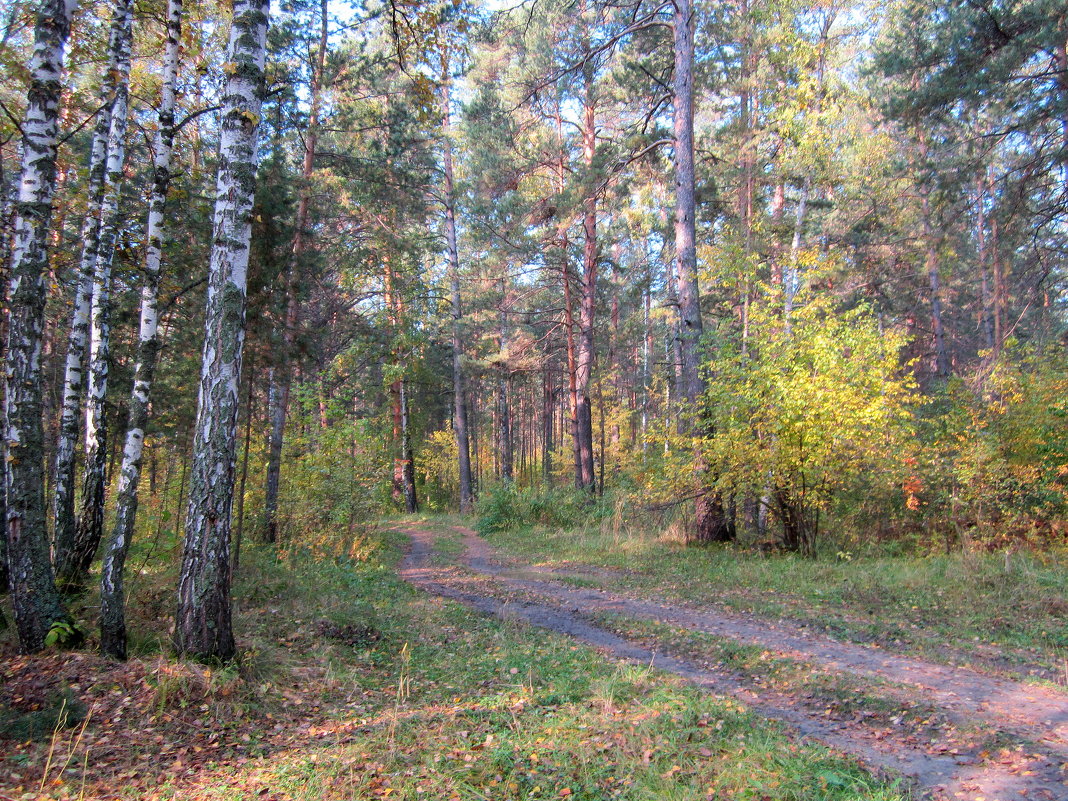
left=673, top=0, right=734, bottom=543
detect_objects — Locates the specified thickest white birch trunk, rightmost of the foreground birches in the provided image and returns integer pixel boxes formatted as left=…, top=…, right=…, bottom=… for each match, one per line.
left=174, top=0, right=268, bottom=660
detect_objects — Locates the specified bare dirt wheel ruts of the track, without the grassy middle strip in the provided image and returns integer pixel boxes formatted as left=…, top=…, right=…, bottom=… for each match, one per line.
left=402, top=527, right=1068, bottom=801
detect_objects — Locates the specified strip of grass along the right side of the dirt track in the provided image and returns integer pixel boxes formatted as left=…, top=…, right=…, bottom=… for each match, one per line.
left=480, top=515, right=1068, bottom=686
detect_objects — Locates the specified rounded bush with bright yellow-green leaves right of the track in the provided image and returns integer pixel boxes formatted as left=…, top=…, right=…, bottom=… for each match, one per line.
left=702, top=296, right=912, bottom=552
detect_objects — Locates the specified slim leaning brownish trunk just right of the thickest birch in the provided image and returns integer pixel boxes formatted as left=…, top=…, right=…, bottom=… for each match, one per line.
left=264, top=0, right=329, bottom=543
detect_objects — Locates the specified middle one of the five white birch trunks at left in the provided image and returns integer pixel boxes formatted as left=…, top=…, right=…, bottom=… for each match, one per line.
left=66, top=2, right=134, bottom=584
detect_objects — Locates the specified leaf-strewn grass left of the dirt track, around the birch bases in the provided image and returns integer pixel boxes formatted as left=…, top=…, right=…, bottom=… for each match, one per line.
left=0, top=523, right=908, bottom=801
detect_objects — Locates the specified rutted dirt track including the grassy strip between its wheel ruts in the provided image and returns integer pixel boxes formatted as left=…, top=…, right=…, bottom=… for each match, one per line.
left=401, top=516, right=1068, bottom=801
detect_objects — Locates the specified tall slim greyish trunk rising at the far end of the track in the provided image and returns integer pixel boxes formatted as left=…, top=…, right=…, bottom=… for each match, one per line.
left=441, top=56, right=474, bottom=514
